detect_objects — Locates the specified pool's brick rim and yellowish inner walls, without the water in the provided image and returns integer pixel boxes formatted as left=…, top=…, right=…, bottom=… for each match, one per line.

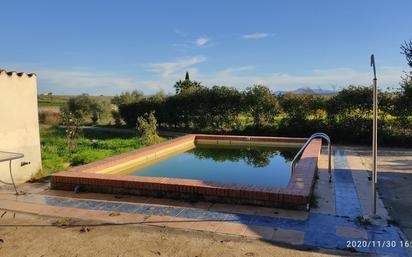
left=51, top=134, right=322, bottom=209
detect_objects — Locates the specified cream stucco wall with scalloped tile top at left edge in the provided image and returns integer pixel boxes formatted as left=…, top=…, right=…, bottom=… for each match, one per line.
left=0, top=70, right=41, bottom=182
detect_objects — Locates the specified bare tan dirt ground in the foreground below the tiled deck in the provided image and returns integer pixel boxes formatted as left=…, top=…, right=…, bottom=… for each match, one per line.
left=0, top=212, right=358, bottom=257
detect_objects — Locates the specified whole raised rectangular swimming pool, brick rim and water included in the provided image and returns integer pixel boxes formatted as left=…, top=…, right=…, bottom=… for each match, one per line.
left=51, top=134, right=322, bottom=208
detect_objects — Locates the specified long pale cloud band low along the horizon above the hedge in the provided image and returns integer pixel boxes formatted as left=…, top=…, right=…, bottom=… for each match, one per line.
left=17, top=63, right=403, bottom=95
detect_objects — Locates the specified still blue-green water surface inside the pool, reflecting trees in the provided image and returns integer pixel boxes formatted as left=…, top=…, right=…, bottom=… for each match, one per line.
left=130, top=145, right=298, bottom=187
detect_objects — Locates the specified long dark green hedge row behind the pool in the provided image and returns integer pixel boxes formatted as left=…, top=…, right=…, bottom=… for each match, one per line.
left=118, top=83, right=412, bottom=145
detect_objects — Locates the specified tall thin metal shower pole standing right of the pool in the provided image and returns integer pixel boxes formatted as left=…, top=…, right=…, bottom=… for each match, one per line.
left=371, top=54, right=378, bottom=215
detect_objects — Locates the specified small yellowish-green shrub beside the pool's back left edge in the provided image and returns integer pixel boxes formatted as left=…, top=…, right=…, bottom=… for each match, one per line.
left=136, top=112, right=160, bottom=145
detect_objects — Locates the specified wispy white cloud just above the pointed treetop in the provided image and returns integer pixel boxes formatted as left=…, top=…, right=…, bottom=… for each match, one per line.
left=149, top=56, right=207, bottom=78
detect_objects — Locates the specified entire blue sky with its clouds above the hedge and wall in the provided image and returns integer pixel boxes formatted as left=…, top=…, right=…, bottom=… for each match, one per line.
left=0, top=0, right=412, bottom=95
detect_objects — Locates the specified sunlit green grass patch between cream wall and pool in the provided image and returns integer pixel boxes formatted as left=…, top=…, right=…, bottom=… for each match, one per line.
left=36, top=128, right=156, bottom=178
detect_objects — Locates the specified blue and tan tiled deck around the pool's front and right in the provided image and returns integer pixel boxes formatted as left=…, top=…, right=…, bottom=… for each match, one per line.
left=0, top=148, right=408, bottom=256
